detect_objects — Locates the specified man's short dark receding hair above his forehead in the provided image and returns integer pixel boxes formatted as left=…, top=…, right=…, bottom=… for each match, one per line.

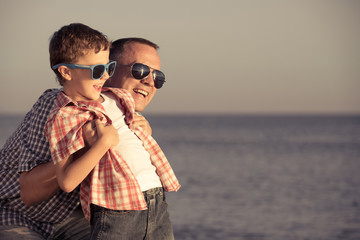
left=109, top=37, right=159, bottom=61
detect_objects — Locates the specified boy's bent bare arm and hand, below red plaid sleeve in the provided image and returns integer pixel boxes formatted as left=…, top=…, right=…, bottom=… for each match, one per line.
left=55, top=119, right=119, bottom=192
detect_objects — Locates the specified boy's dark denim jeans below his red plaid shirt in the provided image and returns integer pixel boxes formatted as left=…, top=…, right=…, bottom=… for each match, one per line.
left=91, top=188, right=174, bottom=240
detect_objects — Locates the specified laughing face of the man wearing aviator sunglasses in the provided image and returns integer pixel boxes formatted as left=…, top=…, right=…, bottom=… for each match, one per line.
left=107, top=43, right=161, bottom=112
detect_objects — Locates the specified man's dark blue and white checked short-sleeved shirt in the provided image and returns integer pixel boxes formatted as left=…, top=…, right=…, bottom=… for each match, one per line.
left=0, top=89, right=79, bottom=238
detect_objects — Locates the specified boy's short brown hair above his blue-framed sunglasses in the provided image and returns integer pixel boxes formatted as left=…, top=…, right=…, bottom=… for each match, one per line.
left=49, top=23, right=111, bottom=85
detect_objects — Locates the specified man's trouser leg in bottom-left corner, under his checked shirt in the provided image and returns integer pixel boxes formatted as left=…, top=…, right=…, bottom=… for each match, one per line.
left=0, top=225, right=45, bottom=240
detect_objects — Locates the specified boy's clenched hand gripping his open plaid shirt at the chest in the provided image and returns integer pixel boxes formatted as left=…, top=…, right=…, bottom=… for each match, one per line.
left=95, top=119, right=119, bottom=148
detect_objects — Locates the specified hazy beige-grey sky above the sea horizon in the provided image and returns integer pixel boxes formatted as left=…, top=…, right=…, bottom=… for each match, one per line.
left=0, top=0, right=360, bottom=114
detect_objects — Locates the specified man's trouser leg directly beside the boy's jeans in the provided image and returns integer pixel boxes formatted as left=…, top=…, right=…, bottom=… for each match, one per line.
left=50, top=206, right=90, bottom=240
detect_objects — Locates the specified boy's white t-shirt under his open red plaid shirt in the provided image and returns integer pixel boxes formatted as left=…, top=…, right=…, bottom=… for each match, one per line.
left=102, top=92, right=162, bottom=192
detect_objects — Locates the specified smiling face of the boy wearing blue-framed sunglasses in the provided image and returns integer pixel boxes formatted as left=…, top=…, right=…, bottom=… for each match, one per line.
left=64, top=51, right=109, bottom=102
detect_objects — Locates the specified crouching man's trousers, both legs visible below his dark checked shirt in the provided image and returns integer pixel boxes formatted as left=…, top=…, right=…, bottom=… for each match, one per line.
left=0, top=205, right=90, bottom=240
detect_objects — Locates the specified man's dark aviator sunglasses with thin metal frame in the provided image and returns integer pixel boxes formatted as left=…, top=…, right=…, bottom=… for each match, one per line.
left=118, top=63, right=165, bottom=89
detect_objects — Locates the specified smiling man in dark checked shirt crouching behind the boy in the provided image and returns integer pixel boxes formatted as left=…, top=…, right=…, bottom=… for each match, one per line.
left=0, top=38, right=174, bottom=240
